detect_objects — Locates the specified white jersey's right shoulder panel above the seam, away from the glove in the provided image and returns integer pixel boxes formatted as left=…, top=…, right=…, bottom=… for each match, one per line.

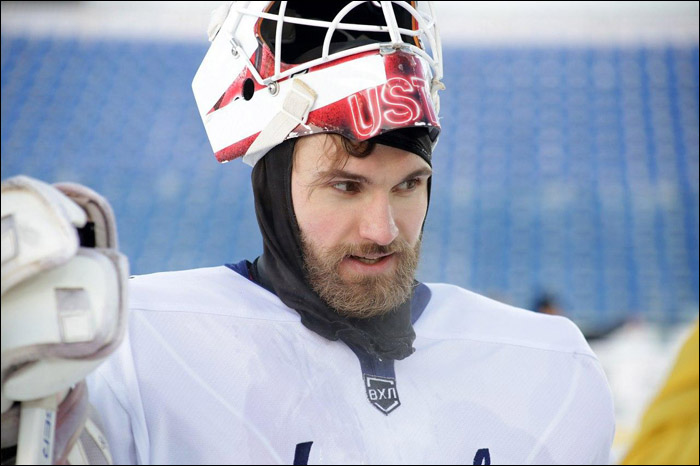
left=416, top=283, right=597, bottom=359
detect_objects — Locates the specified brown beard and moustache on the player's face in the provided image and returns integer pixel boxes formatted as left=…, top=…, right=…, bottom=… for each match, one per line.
left=301, top=233, right=421, bottom=319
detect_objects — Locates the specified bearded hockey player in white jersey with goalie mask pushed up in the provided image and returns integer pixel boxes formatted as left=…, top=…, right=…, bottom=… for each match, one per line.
left=0, top=2, right=614, bottom=464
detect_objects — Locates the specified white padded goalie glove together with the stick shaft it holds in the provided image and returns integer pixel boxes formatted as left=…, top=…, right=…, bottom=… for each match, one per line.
left=1, top=176, right=128, bottom=464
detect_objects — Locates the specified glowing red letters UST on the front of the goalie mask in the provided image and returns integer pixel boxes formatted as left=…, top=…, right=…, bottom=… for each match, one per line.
left=348, top=76, right=429, bottom=139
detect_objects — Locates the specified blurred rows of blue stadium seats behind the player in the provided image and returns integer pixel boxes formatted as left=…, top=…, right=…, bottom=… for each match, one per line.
left=1, top=35, right=699, bottom=322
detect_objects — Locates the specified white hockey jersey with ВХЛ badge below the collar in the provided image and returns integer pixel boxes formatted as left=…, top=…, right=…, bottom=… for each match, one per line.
left=88, top=267, right=614, bottom=464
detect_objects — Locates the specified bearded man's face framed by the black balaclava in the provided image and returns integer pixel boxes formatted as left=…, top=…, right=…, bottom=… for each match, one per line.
left=292, top=134, right=431, bottom=318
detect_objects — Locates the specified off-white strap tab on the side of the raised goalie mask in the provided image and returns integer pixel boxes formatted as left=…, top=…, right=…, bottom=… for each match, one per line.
left=243, top=78, right=316, bottom=167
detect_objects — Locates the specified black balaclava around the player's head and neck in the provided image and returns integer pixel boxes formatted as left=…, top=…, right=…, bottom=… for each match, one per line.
left=250, top=128, right=431, bottom=359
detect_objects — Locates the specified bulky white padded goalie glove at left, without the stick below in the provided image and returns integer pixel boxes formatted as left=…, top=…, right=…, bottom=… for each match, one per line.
left=1, top=177, right=128, bottom=404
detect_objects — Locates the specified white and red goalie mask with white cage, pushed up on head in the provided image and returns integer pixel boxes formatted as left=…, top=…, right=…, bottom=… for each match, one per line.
left=192, top=2, right=444, bottom=165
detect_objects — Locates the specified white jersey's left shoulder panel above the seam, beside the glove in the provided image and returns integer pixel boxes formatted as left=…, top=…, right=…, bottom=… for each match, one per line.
left=129, top=266, right=299, bottom=321
